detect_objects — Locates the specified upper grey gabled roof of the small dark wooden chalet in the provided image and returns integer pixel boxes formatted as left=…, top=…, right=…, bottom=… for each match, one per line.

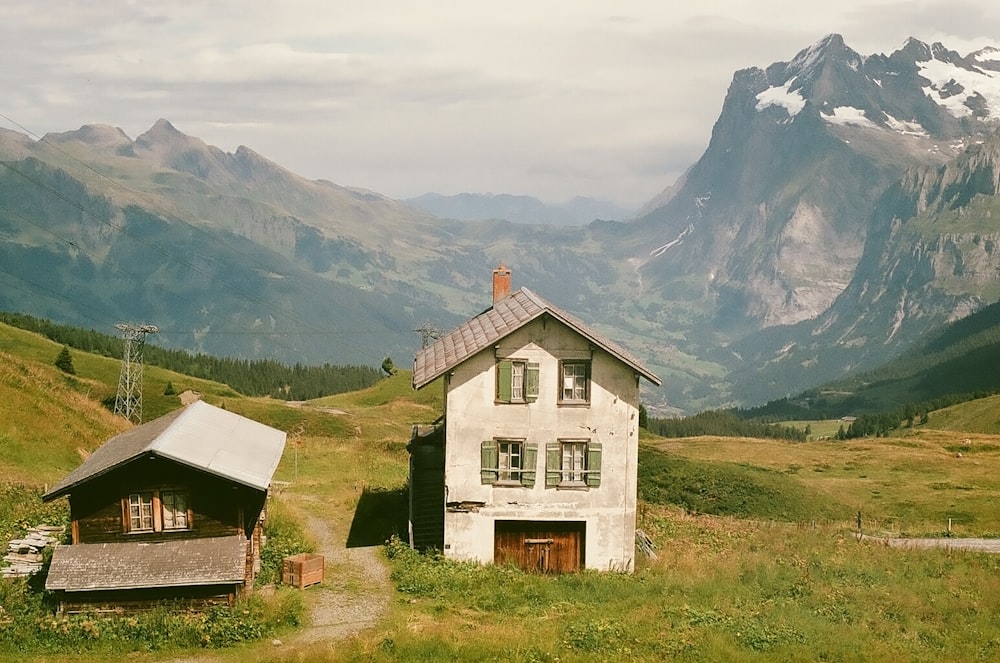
left=42, top=401, right=285, bottom=501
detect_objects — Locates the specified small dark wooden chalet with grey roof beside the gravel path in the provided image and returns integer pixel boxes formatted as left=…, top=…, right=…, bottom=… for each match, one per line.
left=42, top=401, right=285, bottom=612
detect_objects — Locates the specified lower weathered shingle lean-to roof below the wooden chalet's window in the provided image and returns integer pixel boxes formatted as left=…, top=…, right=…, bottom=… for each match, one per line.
left=45, top=535, right=247, bottom=592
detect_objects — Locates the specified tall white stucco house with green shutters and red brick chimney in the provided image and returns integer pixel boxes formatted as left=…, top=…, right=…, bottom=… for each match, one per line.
left=409, top=265, right=660, bottom=572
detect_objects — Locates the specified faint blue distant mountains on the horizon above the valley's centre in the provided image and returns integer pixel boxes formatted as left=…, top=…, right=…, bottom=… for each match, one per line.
left=401, top=193, right=632, bottom=226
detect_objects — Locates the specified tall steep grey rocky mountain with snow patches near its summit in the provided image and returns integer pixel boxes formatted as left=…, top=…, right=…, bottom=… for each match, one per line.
left=635, top=35, right=1000, bottom=328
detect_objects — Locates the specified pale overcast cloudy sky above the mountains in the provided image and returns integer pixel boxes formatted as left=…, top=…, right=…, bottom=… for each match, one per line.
left=0, top=0, right=1000, bottom=207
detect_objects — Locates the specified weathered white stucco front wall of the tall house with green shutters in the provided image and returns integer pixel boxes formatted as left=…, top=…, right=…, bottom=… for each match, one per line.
left=444, top=316, right=639, bottom=570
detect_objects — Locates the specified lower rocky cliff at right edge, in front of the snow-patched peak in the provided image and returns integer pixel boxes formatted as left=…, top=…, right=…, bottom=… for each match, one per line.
left=733, top=127, right=1000, bottom=402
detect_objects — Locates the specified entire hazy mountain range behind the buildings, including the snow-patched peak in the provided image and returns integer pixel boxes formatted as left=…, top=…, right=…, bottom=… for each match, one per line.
left=0, top=35, right=1000, bottom=412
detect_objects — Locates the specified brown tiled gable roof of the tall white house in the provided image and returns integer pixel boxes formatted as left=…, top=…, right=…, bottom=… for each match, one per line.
left=413, top=288, right=660, bottom=389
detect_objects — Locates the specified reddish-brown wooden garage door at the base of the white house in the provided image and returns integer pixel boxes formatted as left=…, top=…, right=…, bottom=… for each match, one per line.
left=493, top=520, right=587, bottom=573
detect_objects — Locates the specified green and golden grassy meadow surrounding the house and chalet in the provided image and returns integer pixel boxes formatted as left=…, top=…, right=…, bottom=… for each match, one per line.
left=0, top=322, right=1000, bottom=663
